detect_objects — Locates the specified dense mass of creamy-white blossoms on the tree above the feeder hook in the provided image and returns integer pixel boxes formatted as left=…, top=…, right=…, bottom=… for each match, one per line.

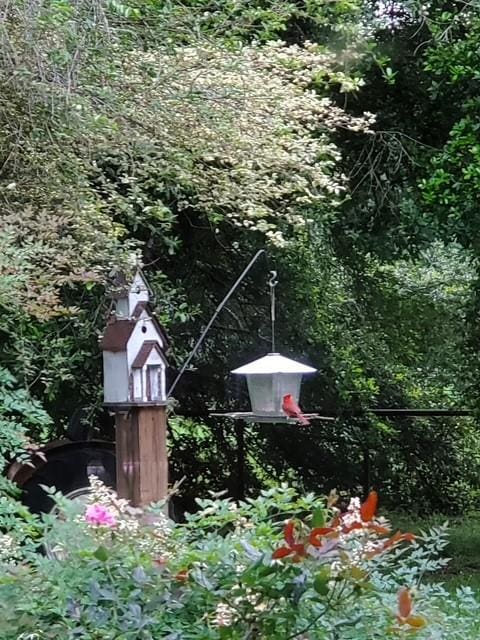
left=113, top=42, right=373, bottom=247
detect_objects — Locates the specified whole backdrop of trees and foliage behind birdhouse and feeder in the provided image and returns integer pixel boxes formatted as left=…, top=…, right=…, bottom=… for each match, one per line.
left=0, top=0, right=480, bottom=513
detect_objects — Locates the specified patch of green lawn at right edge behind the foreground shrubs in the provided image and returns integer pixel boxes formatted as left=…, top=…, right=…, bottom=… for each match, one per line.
left=389, top=513, right=480, bottom=595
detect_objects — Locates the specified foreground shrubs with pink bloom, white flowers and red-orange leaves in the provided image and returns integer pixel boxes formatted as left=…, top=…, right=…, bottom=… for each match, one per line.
left=0, top=479, right=479, bottom=640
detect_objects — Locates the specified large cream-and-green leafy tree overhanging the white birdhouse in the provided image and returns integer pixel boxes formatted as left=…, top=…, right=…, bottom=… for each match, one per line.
left=0, top=0, right=371, bottom=316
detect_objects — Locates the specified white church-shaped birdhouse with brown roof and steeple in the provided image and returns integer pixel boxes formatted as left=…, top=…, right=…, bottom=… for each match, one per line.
left=101, top=273, right=167, bottom=406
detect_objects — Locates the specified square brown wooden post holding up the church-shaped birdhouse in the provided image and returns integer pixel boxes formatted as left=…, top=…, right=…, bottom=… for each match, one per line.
left=115, top=406, right=168, bottom=507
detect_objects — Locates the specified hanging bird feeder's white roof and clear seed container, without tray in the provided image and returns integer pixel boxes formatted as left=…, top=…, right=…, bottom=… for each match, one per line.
left=232, top=353, right=316, bottom=417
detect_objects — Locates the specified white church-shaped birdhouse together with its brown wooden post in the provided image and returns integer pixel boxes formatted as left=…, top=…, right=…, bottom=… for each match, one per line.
left=102, top=273, right=168, bottom=507
